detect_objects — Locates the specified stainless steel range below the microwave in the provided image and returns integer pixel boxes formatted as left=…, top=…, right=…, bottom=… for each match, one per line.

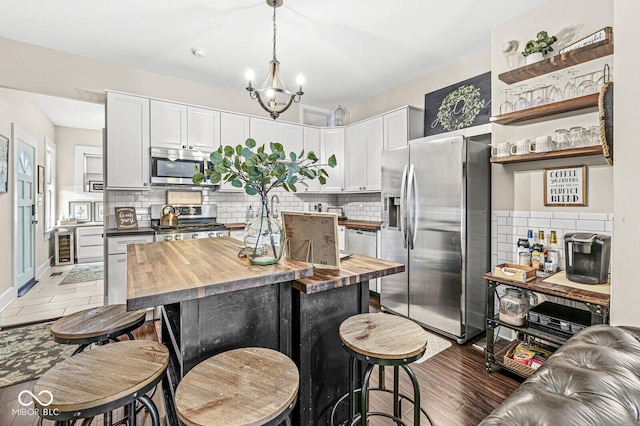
left=151, top=204, right=230, bottom=241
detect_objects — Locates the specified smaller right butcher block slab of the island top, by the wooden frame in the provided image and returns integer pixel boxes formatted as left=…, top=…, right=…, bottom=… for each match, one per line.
left=293, top=254, right=404, bottom=294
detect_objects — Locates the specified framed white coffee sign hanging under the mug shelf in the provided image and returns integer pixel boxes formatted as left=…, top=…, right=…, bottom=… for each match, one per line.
left=544, top=166, right=587, bottom=206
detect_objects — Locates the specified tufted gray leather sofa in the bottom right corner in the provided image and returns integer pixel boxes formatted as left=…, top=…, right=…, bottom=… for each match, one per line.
left=480, top=325, right=640, bottom=426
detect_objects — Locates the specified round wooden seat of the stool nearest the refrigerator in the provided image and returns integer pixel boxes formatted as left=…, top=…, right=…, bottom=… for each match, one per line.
left=339, top=313, right=427, bottom=362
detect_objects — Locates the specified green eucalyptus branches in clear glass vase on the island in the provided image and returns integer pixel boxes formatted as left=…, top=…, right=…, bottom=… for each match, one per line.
left=192, top=138, right=337, bottom=265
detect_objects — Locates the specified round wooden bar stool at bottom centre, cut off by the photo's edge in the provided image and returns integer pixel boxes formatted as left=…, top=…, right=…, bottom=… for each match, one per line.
left=175, top=347, right=300, bottom=426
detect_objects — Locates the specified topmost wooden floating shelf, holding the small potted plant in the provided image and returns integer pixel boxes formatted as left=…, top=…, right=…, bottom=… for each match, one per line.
left=498, top=37, right=613, bottom=84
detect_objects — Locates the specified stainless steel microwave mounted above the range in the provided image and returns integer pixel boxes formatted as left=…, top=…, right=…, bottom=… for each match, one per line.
left=151, top=148, right=211, bottom=185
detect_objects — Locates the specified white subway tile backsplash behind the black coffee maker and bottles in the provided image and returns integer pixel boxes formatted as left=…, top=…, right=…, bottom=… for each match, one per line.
left=491, top=211, right=613, bottom=265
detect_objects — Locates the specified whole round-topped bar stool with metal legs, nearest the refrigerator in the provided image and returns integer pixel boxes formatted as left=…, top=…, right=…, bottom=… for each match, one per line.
left=331, top=313, right=433, bottom=426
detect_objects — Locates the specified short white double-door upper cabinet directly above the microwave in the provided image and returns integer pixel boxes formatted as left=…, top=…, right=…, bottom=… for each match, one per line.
left=150, top=100, right=220, bottom=152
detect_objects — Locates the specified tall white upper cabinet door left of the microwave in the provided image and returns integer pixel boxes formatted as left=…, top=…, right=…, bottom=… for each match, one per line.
left=105, top=92, right=149, bottom=190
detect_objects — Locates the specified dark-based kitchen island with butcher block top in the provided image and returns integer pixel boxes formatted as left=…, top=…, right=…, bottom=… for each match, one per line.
left=127, top=238, right=404, bottom=425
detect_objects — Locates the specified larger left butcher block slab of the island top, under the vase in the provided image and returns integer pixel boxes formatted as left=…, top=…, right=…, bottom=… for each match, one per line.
left=127, top=237, right=313, bottom=310
